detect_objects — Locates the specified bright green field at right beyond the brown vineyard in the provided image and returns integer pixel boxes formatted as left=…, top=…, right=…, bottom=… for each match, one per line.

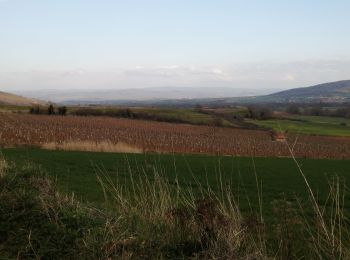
left=249, top=116, right=350, bottom=136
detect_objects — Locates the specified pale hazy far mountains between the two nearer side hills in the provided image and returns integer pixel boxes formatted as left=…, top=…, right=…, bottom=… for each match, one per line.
left=17, top=87, right=277, bottom=104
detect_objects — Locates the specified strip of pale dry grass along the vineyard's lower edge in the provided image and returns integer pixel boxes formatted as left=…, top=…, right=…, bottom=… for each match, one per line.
left=41, top=141, right=142, bottom=153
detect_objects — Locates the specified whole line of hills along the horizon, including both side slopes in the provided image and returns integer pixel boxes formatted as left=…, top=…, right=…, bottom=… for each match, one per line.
left=0, top=80, right=350, bottom=106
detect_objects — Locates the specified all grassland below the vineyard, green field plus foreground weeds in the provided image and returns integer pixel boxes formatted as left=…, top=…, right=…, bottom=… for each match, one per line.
left=0, top=148, right=350, bottom=259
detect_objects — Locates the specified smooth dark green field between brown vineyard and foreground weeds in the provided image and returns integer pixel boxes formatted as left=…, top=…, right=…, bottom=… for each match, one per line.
left=2, top=149, right=350, bottom=219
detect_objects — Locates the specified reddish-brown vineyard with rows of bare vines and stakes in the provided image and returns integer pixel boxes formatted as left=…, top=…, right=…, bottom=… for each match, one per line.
left=0, top=113, right=350, bottom=159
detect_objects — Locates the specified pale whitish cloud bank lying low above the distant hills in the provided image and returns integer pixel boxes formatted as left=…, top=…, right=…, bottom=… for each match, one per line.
left=0, top=59, right=350, bottom=90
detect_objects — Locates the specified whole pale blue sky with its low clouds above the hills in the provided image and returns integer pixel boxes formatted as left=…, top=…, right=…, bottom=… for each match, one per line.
left=0, top=0, right=350, bottom=91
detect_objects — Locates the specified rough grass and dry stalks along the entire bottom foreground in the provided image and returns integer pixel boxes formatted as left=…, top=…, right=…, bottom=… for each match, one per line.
left=0, top=154, right=350, bottom=259
